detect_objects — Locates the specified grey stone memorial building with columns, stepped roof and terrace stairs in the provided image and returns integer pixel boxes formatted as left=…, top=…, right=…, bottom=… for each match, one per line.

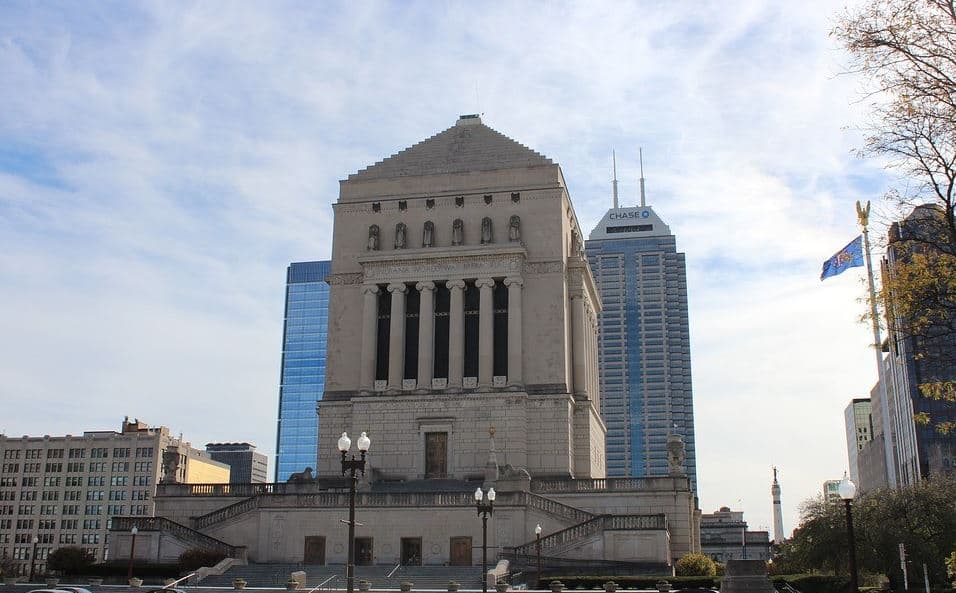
left=117, top=115, right=700, bottom=571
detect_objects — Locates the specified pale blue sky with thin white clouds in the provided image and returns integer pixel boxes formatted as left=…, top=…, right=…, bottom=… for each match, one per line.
left=0, top=0, right=899, bottom=532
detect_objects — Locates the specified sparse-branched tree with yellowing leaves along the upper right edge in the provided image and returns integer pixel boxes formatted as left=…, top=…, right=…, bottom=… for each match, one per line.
left=832, top=0, right=956, bottom=430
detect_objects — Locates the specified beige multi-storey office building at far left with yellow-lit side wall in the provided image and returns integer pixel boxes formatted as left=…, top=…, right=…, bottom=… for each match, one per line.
left=0, top=418, right=229, bottom=574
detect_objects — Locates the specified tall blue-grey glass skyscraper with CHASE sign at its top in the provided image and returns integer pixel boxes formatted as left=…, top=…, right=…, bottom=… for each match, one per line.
left=585, top=206, right=697, bottom=489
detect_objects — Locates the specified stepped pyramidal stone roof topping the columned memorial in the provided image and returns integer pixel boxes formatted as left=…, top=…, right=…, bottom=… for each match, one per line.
left=348, top=115, right=554, bottom=181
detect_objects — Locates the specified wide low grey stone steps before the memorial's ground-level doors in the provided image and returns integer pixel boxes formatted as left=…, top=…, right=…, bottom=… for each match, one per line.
left=200, top=564, right=481, bottom=591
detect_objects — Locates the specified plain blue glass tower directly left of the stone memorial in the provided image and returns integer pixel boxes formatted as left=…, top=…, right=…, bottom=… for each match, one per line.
left=276, top=261, right=332, bottom=482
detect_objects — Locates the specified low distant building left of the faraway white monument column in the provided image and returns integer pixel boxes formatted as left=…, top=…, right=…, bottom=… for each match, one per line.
left=700, top=507, right=770, bottom=563
